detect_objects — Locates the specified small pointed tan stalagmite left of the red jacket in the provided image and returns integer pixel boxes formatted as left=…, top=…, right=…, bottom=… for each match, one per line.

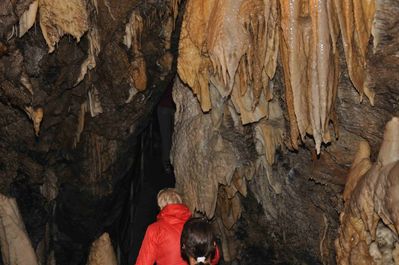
left=87, top=233, right=118, bottom=265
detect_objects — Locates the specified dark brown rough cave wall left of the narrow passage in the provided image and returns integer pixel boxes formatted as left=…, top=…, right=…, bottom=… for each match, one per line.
left=0, top=0, right=178, bottom=265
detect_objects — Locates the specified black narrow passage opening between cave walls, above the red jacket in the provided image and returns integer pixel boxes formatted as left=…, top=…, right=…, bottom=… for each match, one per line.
left=111, top=108, right=175, bottom=265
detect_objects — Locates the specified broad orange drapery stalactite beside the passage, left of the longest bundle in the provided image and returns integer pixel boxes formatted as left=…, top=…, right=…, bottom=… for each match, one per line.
left=178, top=0, right=279, bottom=124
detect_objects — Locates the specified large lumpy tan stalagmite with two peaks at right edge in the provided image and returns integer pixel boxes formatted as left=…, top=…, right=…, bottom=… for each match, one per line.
left=335, top=117, right=399, bottom=265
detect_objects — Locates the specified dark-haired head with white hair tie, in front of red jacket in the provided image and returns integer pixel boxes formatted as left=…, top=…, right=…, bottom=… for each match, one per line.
left=180, top=218, right=216, bottom=265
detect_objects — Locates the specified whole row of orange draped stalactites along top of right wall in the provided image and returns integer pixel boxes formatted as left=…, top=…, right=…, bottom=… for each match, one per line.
left=178, top=0, right=375, bottom=154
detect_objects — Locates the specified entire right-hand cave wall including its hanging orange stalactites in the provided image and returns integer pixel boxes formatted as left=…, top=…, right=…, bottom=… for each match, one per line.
left=172, top=0, right=399, bottom=264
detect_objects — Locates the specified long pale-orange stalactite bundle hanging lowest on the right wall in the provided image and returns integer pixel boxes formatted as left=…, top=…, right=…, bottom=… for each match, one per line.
left=280, top=0, right=338, bottom=153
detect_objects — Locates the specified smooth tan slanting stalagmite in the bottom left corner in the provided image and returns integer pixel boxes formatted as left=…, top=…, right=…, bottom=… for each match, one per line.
left=0, top=194, right=38, bottom=265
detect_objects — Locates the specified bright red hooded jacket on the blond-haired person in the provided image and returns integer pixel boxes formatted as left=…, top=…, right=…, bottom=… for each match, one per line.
left=136, top=204, right=220, bottom=265
